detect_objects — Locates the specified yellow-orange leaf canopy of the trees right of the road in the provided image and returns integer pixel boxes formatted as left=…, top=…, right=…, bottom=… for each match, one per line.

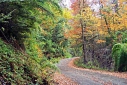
left=69, top=0, right=127, bottom=46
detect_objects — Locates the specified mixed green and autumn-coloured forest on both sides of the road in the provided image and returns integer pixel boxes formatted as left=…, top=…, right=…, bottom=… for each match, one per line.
left=0, top=0, right=127, bottom=85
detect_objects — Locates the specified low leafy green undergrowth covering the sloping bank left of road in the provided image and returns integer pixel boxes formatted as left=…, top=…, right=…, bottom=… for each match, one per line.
left=0, top=39, right=56, bottom=85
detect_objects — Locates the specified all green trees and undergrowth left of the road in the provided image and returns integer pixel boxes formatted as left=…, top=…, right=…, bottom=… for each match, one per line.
left=0, top=0, right=70, bottom=85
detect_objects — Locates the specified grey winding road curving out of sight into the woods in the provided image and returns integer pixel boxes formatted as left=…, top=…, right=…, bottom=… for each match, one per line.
left=57, top=58, right=127, bottom=85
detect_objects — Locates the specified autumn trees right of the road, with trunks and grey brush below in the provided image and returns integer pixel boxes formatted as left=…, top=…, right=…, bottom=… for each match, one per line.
left=65, top=0, right=127, bottom=69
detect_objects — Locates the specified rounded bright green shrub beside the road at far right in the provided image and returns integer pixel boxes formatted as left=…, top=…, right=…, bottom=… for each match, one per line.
left=112, top=43, right=127, bottom=71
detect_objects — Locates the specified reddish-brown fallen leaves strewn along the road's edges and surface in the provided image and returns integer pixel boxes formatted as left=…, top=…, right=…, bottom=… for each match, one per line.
left=53, top=57, right=127, bottom=85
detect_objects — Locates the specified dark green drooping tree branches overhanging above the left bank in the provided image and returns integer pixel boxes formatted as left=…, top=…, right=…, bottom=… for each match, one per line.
left=0, top=0, right=61, bottom=44
